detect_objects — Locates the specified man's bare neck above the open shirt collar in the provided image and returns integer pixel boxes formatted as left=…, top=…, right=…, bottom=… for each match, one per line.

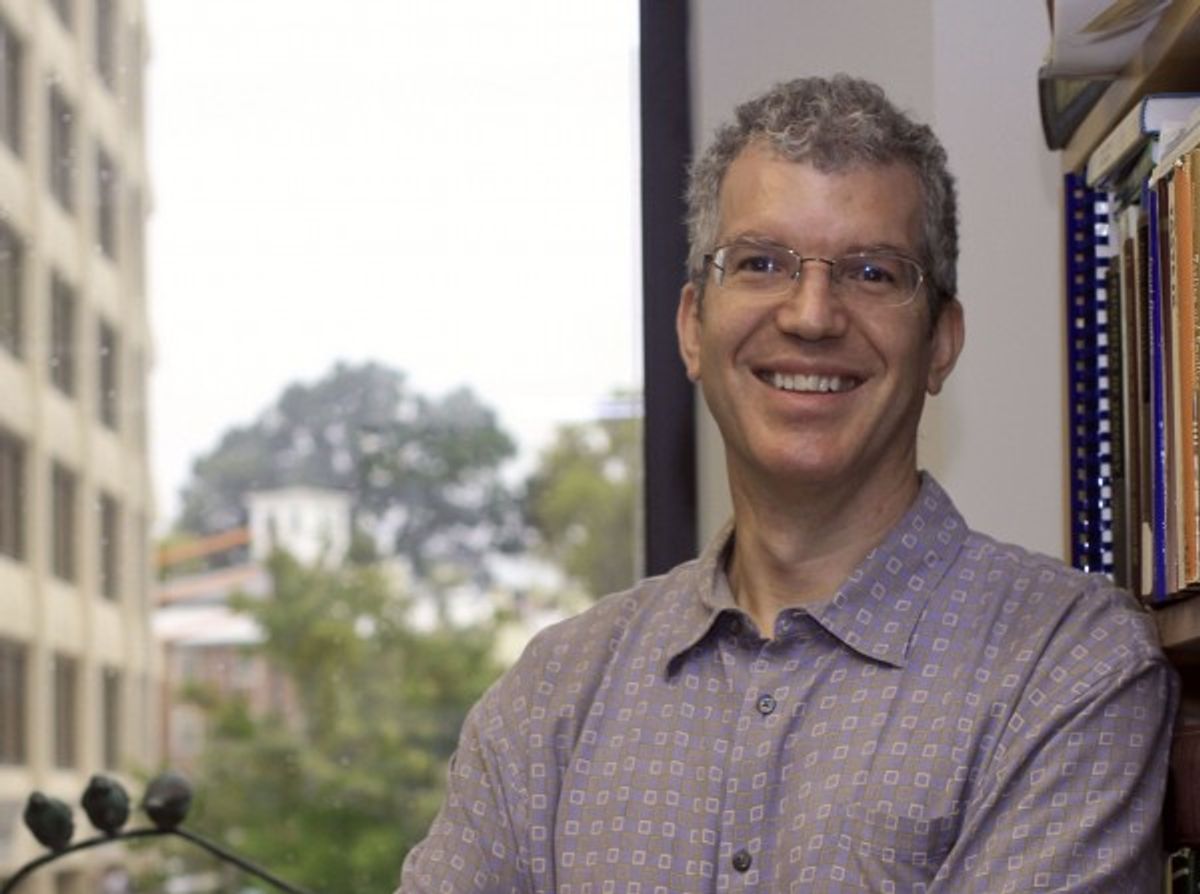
left=728, top=472, right=919, bottom=637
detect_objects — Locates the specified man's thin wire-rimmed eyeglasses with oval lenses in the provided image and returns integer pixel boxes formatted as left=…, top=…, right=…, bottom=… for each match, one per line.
left=704, top=241, right=925, bottom=307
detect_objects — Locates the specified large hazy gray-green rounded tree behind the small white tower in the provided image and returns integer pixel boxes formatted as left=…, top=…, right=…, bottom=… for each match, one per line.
left=178, top=362, right=523, bottom=575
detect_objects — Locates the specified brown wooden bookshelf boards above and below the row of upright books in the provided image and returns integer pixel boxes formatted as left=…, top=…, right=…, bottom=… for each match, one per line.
left=1062, top=0, right=1200, bottom=667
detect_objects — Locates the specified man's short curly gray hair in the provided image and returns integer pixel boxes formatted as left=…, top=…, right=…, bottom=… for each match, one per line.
left=688, top=74, right=959, bottom=320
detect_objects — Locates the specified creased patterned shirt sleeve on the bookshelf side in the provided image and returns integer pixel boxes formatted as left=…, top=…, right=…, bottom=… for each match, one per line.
left=929, top=656, right=1178, bottom=894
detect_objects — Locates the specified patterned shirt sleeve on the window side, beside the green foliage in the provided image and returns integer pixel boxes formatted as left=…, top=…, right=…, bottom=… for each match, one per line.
left=396, top=689, right=533, bottom=894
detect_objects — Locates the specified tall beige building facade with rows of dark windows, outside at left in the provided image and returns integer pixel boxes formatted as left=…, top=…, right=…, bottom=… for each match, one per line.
left=0, top=0, right=161, bottom=894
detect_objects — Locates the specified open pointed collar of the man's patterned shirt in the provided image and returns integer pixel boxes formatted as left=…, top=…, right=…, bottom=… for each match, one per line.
left=666, top=473, right=967, bottom=667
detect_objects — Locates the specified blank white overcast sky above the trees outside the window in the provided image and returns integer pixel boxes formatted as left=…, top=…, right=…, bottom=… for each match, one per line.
left=146, top=0, right=641, bottom=524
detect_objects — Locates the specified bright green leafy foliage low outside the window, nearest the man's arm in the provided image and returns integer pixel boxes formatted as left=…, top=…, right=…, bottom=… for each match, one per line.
left=192, top=553, right=498, bottom=893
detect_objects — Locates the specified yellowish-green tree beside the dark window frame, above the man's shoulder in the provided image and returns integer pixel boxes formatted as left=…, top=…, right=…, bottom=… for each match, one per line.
left=526, top=398, right=642, bottom=596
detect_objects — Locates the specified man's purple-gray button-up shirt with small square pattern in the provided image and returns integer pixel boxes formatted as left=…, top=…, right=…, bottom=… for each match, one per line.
left=400, top=475, right=1177, bottom=894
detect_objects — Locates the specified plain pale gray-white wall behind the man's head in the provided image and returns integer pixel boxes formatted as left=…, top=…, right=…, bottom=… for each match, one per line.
left=691, top=0, right=1066, bottom=556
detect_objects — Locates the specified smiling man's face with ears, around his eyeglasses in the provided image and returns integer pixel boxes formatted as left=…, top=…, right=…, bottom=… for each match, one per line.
left=677, top=145, right=962, bottom=499
